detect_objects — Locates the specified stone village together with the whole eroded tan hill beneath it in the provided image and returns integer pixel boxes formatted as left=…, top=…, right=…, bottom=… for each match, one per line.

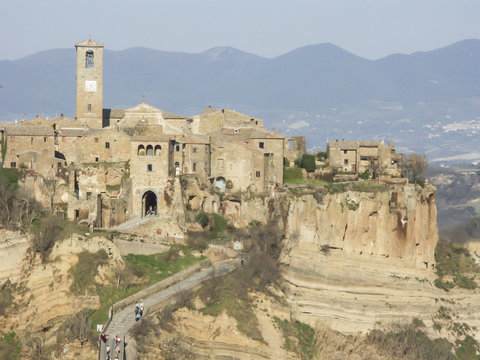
left=0, top=40, right=472, bottom=360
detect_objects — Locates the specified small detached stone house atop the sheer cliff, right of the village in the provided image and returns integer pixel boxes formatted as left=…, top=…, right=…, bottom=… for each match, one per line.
left=327, top=140, right=402, bottom=176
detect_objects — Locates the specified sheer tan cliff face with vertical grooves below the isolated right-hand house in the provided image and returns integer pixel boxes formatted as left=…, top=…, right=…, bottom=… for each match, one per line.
left=284, top=185, right=438, bottom=269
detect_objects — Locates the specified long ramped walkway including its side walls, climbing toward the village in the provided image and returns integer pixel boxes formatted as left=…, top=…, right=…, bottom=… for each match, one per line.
left=98, top=259, right=240, bottom=360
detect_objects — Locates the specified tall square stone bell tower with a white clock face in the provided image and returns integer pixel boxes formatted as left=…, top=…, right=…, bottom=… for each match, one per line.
left=75, top=39, right=103, bottom=129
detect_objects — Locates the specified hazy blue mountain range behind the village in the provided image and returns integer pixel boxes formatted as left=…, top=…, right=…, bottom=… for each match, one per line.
left=0, top=40, right=480, bottom=158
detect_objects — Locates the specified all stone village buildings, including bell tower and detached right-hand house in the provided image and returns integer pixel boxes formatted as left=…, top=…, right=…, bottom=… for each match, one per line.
left=0, top=39, right=401, bottom=231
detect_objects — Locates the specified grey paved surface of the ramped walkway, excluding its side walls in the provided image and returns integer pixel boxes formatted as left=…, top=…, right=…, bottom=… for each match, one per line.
left=99, top=259, right=240, bottom=360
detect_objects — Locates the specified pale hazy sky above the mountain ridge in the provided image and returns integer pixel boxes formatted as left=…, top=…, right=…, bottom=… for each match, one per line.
left=0, top=0, right=480, bottom=59
